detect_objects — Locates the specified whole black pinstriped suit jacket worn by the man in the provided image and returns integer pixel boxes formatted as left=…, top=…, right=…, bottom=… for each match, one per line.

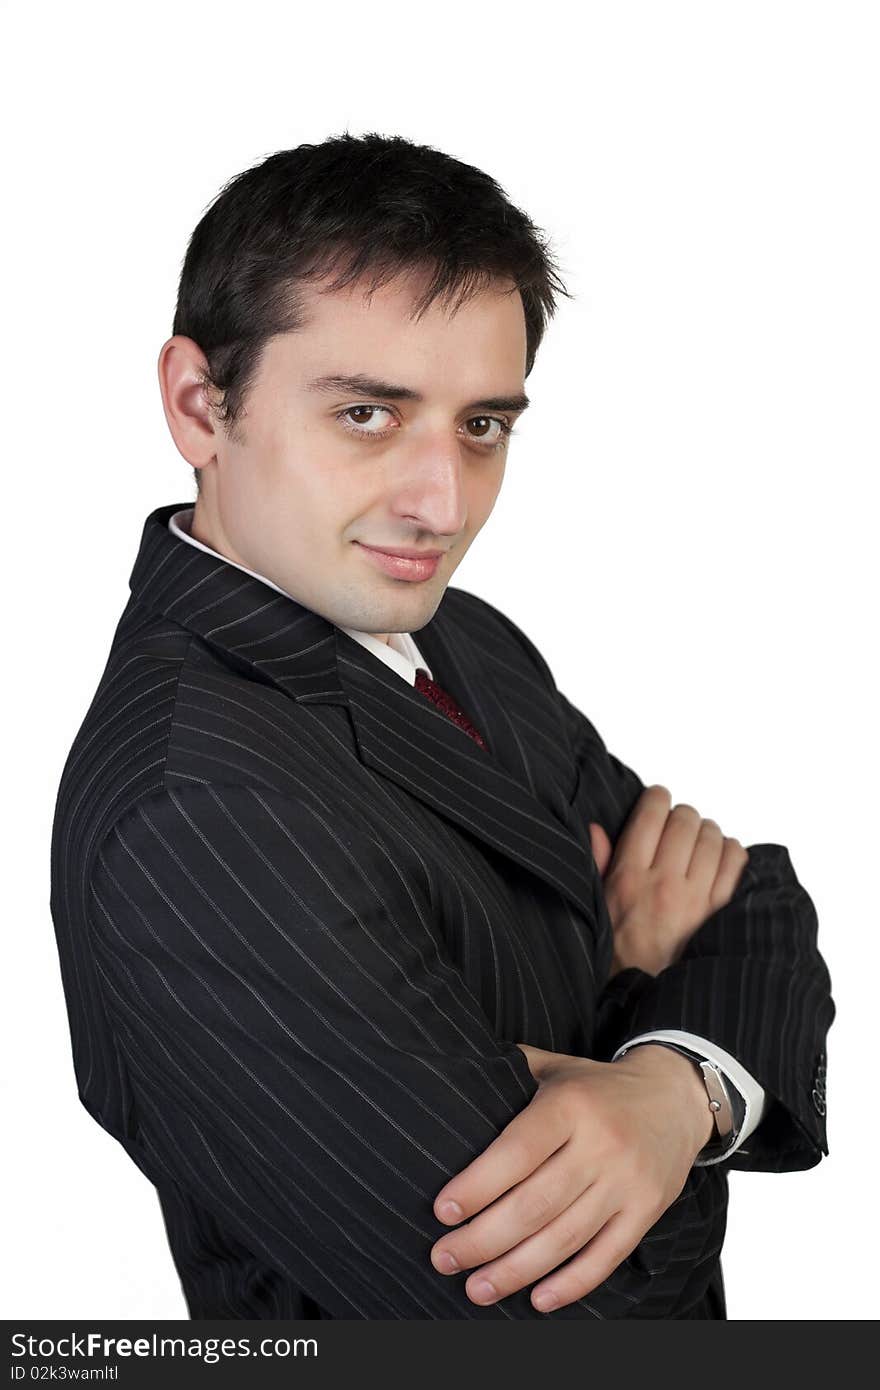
left=51, top=502, right=834, bottom=1319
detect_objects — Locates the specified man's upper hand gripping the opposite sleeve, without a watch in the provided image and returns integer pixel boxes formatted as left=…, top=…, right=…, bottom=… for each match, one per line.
left=589, top=785, right=748, bottom=979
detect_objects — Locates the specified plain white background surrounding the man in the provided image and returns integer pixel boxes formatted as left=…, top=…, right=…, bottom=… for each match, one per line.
left=0, top=0, right=880, bottom=1319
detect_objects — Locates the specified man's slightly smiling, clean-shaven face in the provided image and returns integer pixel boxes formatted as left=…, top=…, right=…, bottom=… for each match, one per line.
left=171, top=265, right=525, bottom=638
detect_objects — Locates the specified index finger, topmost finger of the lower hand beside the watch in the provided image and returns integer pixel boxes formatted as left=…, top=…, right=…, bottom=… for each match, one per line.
left=434, top=1091, right=571, bottom=1222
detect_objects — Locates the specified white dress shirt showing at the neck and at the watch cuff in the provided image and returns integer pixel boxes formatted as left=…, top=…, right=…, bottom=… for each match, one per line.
left=168, top=507, right=766, bottom=1168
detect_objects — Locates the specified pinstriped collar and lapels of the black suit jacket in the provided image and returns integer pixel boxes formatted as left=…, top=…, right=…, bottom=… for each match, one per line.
left=129, top=502, right=598, bottom=927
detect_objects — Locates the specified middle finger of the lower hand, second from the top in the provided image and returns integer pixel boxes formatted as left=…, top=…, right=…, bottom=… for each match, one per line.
left=431, top=1144, right=595, bottom=1277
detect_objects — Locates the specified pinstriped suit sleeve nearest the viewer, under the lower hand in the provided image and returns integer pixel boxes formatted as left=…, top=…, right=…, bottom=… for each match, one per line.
left=84, top=784, right=724, bottom=1321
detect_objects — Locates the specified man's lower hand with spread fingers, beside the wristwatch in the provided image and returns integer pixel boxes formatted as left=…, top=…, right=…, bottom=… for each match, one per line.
left=431, top=1043, right=715, bottom=1312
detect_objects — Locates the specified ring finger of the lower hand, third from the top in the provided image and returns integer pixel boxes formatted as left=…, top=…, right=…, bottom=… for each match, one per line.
left=450, top=1183, right=614, bottom=1304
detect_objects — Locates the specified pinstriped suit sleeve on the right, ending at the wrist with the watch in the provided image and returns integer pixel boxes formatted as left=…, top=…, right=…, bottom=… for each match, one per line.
left=492, top=609, right=836, bottom=1172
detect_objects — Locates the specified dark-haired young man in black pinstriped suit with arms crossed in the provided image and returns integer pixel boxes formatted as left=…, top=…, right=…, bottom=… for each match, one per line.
left=51, top=135, right=834, bottom=1319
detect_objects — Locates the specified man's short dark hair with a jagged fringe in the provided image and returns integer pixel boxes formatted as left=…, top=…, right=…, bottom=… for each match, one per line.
left=172, top=131, right=571, bottom=487
